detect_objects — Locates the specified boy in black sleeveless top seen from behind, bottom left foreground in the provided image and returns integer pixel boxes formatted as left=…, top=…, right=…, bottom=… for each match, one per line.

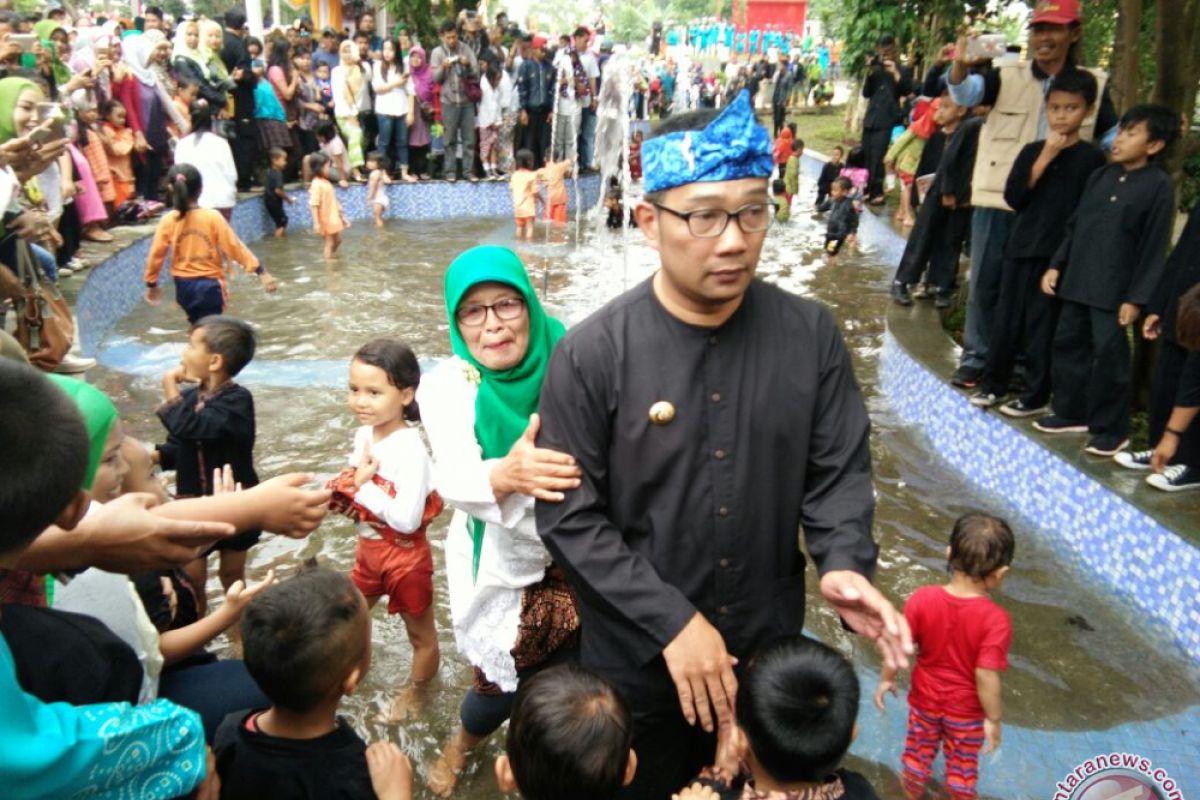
left=212, top=569, right=412, bottom=800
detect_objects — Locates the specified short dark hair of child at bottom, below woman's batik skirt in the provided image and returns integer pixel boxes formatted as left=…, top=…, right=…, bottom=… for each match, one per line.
left=504, top=663, right=634, bottom=800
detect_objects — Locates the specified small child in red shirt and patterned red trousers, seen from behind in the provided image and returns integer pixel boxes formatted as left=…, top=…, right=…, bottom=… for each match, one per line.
left=875, top=513, right=1015, bottom=800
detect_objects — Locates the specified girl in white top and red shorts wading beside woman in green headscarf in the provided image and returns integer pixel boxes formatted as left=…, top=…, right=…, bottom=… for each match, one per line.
left=329, top=338, right=443, bottom=722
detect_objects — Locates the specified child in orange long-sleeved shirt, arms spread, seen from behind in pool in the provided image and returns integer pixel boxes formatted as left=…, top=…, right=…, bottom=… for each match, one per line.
left=145, top=164, right=275, bottom=325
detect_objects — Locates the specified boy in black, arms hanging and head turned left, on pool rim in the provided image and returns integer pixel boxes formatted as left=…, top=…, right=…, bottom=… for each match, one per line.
left=1033, top=106, right=1180, bottom=457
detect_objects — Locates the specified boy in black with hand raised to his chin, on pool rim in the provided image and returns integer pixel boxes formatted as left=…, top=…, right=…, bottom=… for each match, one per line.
left=971, top=68, right=1104, bottom=417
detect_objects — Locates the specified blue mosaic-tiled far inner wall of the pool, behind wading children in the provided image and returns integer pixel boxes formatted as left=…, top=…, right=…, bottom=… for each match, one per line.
left=76, top=175, right=600, bottom=355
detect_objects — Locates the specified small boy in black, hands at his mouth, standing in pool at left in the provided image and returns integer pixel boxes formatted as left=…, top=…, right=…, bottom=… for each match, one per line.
left=158, top=314, right=263, bottom=623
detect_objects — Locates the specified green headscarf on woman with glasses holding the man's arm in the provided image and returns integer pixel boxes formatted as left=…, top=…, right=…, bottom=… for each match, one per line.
left=445, top=245, right=566, bottom=577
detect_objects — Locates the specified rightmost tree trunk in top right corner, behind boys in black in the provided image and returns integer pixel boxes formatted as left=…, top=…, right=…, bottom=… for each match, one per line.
left=1151, top=0, right=1200, bottom=186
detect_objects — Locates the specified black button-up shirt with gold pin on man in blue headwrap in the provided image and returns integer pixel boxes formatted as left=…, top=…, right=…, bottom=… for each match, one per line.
left=536, top=281, right=877, bottom=708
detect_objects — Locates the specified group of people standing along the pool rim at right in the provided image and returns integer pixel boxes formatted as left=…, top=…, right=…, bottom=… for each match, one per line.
left=863, top=2, right=1200, bottom=492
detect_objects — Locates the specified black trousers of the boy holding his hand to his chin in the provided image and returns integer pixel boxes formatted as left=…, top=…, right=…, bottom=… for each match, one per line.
left=980, top=258, right=1058, bottom=408
